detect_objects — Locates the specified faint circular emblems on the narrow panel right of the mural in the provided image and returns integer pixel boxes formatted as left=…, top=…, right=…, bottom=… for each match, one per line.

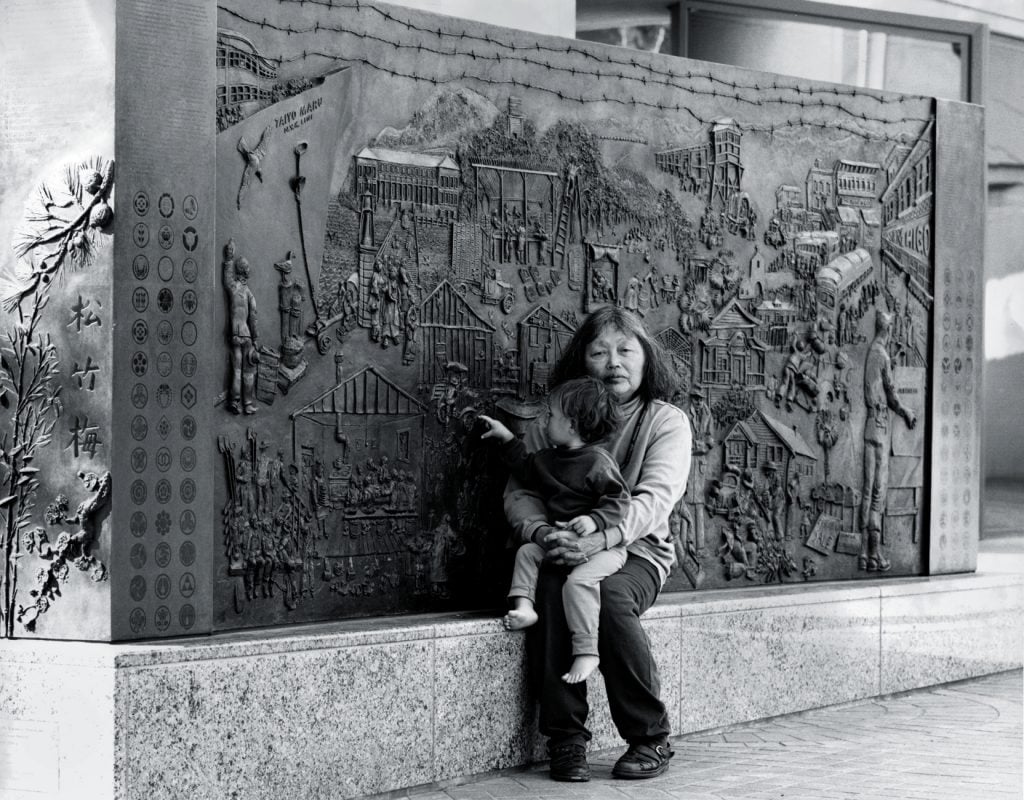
left=938, top=267, right=980, bottom=550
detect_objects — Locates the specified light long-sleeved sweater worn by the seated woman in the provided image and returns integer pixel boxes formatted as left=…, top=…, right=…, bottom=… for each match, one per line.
left=505, top=398, right=692, bottom=584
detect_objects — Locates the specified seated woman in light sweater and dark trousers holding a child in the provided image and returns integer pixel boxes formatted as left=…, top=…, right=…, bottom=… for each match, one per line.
left=505, top=306, right=691, bottom=781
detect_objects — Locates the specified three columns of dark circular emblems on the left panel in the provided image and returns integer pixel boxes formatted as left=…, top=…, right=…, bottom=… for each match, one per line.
left=129, top=192, right=200, bottom=634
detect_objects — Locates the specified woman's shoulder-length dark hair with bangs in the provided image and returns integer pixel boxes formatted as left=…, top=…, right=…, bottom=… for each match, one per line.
left=551, top=305, right=678, bottom=402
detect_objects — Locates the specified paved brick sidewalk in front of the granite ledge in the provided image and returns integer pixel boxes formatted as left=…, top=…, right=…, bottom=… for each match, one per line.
left=405, top=670, right=1024, bottom=800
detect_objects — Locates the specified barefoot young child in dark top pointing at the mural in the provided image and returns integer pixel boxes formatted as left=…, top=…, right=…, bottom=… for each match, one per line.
left=480, top=377, right=630, bottom=683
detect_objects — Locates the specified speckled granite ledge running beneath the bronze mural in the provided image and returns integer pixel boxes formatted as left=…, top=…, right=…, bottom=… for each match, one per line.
left=0, top=575, right=1024, bottom=800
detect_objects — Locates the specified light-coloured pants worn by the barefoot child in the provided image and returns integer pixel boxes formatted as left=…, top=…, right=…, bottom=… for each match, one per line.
left=509, top=542, right=626, bottom=656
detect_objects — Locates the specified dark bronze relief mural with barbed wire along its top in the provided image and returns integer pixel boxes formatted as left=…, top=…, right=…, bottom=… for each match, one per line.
left=205, top=3, right=933, bottom=626
